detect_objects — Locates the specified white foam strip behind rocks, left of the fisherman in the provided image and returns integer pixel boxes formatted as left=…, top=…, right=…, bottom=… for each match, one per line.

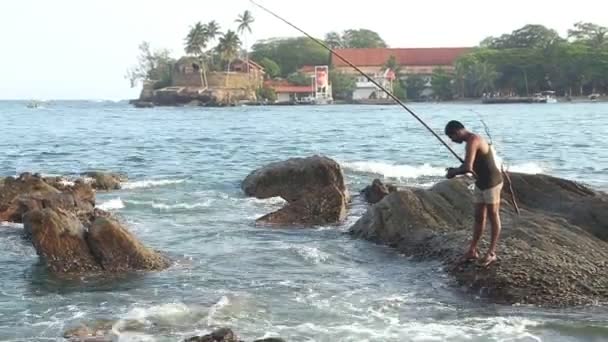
left=342, top=161, right=445, bottom=178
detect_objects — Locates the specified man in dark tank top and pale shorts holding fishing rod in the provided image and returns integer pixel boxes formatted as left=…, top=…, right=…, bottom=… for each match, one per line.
left=445, top=121, right=503, bottom=266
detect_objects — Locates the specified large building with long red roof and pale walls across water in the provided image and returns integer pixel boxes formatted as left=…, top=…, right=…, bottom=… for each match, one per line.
left=332, top=47, right=471, bottom=100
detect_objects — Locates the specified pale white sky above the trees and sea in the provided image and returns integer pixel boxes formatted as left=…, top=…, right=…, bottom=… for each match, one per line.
left=0, top=0, right=608, bottom=100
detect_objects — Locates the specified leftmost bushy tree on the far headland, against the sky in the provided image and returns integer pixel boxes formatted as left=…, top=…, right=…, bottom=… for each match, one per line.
left=125, top=42, right=175, bottom=89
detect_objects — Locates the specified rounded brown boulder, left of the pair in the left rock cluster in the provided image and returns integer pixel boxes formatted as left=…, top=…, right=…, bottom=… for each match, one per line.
left=23, top=208, right=101, bottom=273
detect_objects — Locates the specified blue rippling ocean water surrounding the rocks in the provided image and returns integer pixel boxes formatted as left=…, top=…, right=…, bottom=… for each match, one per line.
left=0, top=102, right=608, bottom=341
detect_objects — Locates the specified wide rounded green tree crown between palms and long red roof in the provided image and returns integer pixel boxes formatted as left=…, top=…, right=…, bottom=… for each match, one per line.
left=250, top=37, right=329, bottom=76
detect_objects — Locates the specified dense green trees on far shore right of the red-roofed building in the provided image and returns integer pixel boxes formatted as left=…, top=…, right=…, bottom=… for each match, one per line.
left=455, top=22, right=608, bottom=96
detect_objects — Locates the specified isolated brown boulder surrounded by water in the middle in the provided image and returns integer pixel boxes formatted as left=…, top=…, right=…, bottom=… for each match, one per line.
left=241, top=156, right=348, bottom=225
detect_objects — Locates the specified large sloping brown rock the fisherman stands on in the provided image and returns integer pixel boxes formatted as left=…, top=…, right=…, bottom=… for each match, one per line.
left=350, top=174, right=608, bottom=306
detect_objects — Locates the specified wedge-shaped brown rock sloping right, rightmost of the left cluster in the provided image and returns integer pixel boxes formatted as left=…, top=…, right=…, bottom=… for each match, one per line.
left=87, top=217, right=170, bottom=272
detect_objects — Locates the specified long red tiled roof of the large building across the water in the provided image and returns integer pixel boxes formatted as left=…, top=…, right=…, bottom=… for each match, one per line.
left=332, top=47, right=471, bottom=67
